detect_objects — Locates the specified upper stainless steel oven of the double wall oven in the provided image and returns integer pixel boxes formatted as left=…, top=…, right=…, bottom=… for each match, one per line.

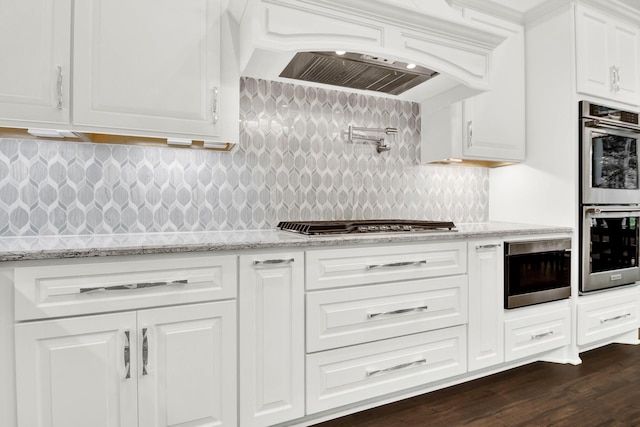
left=580, top=101, right=640, bottom=205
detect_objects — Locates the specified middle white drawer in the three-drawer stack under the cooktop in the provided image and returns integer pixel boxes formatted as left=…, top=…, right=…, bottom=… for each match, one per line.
left=307, top=275, right=467, bottom=352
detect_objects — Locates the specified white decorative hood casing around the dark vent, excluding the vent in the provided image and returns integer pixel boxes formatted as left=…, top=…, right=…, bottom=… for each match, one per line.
left=239, top=0, right=505, bottom=108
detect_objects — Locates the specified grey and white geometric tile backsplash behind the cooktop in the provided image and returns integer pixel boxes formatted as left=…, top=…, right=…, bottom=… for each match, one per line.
left=0, top=78, right=489, bottom=236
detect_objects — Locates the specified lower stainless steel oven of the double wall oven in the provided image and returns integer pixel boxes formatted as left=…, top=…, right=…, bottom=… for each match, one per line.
left=580, top=205, right=640, bottom=292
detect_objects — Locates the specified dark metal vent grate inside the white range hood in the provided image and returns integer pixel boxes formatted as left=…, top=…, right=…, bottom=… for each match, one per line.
left=280, top=52, right=438, bottom=95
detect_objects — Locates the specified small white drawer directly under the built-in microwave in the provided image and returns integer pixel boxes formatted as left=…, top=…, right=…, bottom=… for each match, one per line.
left=504, top=308, right=571, bottom=362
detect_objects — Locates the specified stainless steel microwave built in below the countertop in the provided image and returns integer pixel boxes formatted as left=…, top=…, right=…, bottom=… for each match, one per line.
left=504, top=238, right=571, bottom=308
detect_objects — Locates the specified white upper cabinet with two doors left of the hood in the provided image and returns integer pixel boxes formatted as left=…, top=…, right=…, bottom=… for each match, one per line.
left=0, top=0, right=240, bottom=142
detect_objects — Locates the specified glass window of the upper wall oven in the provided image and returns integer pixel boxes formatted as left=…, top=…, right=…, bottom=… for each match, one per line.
left=591, top=133, right=638, bottom=190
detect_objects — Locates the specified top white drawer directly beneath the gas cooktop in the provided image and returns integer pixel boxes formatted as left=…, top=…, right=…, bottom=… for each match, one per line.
left=306, top=242, right=467, bottom=290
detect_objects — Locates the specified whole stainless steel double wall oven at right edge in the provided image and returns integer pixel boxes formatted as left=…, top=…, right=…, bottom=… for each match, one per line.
left=579, top=101, right=640, bottom=293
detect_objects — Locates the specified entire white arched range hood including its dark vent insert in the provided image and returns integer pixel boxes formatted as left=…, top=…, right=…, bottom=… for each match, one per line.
left=232, top=0, right=504, bottom=111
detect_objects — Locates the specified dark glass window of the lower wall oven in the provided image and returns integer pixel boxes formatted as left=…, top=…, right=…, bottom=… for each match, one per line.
left=589, top=216, right=639, bottom=273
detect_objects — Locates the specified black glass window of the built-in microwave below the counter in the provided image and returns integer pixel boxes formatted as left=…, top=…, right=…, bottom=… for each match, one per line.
left=506, top=251, right=571, bottom=295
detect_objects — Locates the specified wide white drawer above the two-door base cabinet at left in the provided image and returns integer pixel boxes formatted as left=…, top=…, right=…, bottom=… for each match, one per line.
left=15, top=254, right=237, bottom=321
